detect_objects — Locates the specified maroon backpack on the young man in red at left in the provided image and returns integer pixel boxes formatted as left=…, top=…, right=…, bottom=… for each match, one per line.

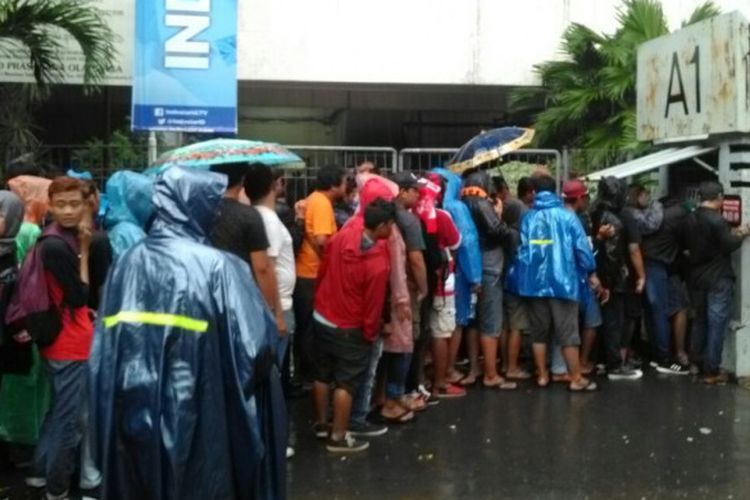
left=5, top=224, right=78, bottom=347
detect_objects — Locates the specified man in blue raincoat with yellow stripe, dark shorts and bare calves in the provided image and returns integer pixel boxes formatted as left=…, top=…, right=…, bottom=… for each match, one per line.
left=509, top=175, right=601, bottom=391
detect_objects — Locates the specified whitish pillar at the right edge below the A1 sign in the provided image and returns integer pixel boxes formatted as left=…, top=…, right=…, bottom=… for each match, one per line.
left=719, top=138, right=750, bottom=377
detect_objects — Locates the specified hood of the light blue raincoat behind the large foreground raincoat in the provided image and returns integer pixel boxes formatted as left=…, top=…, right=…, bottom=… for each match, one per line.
left=105, top=170, right=154, bottom=229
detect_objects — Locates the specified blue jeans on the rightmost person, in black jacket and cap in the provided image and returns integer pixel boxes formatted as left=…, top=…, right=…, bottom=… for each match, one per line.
left=690, top=278, right=734, bottom=375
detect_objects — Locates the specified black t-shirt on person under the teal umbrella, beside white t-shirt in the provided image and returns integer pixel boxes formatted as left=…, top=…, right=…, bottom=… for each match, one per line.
left=211, top=198, right=268, bottom=269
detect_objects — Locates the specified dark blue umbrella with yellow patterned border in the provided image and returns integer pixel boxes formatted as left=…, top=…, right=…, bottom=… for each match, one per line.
left=448, top=127, right=534, bottom=173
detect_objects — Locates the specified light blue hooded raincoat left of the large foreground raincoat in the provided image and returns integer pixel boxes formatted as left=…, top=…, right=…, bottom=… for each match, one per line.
left=104, top=170, right=154, bottom=259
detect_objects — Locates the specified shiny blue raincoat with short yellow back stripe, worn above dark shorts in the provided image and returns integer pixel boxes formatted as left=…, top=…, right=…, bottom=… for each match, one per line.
left=509, top=191, right=596, bottom=301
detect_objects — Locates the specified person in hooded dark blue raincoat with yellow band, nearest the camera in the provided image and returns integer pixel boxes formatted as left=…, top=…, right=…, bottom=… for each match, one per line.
left=90, top=167, right=287, bottom=500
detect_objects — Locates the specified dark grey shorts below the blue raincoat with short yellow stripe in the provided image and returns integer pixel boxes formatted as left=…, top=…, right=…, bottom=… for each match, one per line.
left=526, top=298, right=581, bottom=347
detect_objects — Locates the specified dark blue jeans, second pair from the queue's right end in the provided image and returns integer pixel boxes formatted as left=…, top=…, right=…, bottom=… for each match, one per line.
left=645, top=260, right=672, bottom=362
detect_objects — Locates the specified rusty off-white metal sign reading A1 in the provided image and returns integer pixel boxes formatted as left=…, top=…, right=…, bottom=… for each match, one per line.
left=637, top=12, right=750, bottom=142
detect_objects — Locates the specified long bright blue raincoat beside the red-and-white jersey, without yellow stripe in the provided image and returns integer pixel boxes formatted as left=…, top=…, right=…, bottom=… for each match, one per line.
left=433, top=168, right=482, bottom=326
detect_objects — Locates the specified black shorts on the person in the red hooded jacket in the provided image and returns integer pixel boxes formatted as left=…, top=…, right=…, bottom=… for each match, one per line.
left=313, top=320, right=372, bottom=395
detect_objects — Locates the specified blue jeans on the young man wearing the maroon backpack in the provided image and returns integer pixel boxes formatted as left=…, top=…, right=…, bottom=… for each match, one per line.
left=32, top=359, right=88, bottom=495
